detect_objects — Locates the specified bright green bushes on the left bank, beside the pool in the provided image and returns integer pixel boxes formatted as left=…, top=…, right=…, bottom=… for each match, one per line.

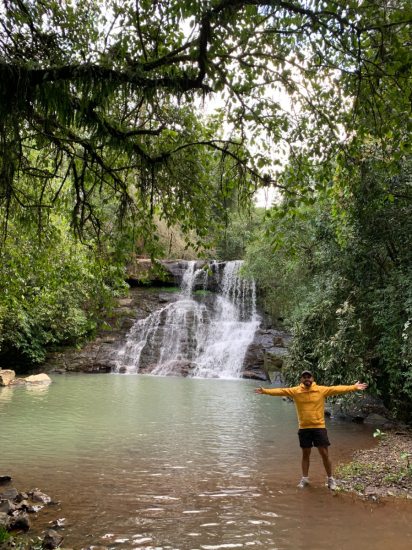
left=0, top=209, right=124, bottom=368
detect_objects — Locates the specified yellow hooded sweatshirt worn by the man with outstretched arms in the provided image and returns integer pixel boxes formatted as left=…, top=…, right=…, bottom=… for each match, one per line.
left=262, top=382, right=357, bottom=429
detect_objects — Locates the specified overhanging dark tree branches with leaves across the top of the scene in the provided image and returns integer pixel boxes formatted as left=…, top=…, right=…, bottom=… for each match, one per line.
left=0, top=0, right=410, bottom=244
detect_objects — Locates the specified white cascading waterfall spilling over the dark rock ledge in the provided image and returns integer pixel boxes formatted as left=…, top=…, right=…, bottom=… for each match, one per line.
left=116, top=261, right=260, bottom=378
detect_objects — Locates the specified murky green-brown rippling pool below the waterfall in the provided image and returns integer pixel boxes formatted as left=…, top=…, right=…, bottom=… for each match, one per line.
left=0, top=375, right=412, bottom=550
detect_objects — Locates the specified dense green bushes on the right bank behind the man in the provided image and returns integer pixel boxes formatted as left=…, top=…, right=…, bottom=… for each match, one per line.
left=247, top=157, right=412, bottom=419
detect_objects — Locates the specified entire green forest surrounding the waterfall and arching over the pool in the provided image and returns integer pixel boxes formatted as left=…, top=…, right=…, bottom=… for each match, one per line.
left=0, top=0, right=412, bottom=421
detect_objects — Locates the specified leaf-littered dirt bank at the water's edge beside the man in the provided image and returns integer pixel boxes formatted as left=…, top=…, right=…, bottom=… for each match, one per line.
left=336, top=430, right=412, bottom=500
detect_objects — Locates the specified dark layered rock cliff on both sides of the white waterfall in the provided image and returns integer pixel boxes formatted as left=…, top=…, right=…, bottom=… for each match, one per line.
left=42, top=259, right=290, bottom=381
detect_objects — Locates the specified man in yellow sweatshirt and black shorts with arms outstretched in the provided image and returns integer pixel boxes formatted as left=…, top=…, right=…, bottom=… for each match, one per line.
left=255, top=370, right=368, bottom=490
